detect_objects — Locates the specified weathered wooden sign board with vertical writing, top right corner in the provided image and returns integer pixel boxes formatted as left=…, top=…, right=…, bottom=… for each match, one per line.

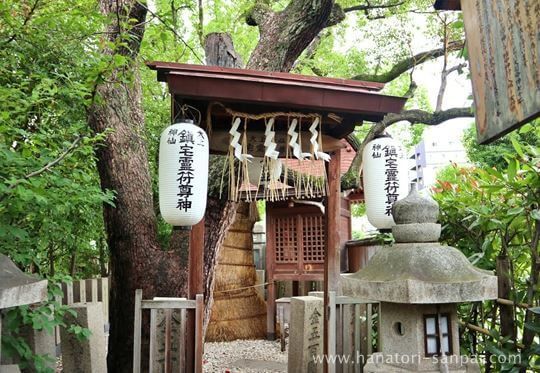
left=435, top=0, right=540, bottom=144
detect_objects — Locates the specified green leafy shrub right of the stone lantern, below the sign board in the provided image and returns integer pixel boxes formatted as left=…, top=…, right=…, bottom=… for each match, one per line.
left=434, top=141, right=540, bottom=371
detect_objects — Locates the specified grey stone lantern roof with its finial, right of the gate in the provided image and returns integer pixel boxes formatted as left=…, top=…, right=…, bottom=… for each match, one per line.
left=342, top=189, right=497, bottom=304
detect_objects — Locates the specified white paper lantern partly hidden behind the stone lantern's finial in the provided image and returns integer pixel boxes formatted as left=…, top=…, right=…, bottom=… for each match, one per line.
left=362, top=136, right=409, bottom=229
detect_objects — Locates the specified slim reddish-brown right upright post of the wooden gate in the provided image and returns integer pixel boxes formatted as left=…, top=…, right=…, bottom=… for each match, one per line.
left=323, top=152, right=341, bottom=372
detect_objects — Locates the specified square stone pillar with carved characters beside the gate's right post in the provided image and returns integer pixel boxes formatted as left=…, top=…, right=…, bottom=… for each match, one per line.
left=287, top=296, right=323, bottom=373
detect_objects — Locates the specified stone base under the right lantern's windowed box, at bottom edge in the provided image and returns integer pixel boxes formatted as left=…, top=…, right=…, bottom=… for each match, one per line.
left=364, top=352, right=480, bottom=373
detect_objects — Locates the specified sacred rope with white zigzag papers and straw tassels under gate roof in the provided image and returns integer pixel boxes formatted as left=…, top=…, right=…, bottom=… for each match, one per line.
left=208, top=101, right=332, bottom=201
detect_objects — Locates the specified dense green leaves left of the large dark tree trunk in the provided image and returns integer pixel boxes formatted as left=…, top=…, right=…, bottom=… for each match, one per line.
left=0, top=0, right=112, bottom=276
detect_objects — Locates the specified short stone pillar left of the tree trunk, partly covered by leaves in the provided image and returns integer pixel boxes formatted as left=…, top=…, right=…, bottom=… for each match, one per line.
left=60, top=303, right=107, bottom=373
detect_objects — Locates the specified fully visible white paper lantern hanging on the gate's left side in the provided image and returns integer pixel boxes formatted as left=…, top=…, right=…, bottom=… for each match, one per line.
left=159, top=120, right=209, bottom=226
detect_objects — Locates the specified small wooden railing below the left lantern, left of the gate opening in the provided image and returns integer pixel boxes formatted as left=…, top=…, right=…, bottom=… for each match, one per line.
left=133, top=289, right=204, bottom=373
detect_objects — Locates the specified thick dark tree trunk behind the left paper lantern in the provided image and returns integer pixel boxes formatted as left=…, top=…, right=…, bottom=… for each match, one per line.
left=88, top=0, right=186, bottom=373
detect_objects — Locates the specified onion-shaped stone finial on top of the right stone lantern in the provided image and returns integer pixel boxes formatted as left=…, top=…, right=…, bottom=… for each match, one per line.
left=392, top=188, right=441, bottom=243
